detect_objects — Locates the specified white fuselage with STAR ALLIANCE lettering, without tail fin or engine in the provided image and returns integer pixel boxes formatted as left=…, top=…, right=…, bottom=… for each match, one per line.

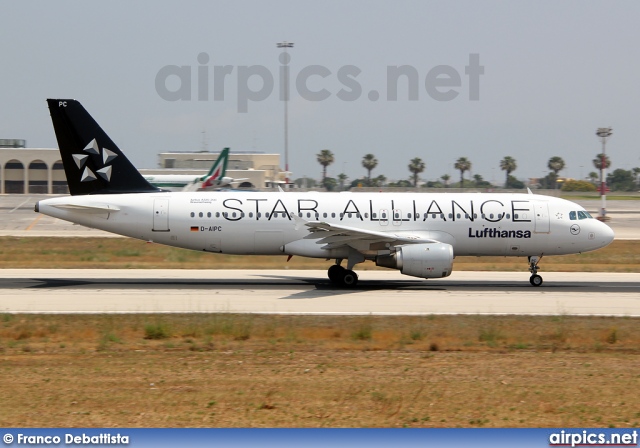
left=37, top=191, right=613, bottom=258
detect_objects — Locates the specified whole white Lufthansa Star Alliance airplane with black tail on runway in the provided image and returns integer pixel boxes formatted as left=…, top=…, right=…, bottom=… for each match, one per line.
left=35, top=99, right=614, bottom=288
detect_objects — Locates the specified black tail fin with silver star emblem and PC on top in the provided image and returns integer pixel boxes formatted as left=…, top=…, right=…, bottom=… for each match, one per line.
left=47, top=99, right=162, bottom=195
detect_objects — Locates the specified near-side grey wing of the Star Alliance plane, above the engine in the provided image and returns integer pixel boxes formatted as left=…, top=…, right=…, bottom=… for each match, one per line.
left=294, top=220, right=440, bottom=250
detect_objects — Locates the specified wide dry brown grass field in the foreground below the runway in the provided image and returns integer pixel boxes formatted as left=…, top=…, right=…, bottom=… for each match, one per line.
left=0, top=314, right=640, bottom=427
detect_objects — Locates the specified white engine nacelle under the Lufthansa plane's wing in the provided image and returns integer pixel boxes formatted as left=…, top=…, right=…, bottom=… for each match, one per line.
left=376, top=243, right=453, bottom=278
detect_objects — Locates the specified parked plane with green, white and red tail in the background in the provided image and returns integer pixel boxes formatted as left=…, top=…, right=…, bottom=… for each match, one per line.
left=142, top=148, right=234, bottom=191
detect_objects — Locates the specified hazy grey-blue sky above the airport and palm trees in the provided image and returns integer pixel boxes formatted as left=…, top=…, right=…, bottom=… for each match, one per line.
left=0, top=1, right=640, bottom=183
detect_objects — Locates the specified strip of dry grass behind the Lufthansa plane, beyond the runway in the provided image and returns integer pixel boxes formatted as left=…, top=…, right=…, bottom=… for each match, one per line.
left=0, top=237, right=640, bottom=272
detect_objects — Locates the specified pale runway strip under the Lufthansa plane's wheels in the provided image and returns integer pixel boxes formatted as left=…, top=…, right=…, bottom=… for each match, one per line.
left=0, top=269, right=640, bottom=317
